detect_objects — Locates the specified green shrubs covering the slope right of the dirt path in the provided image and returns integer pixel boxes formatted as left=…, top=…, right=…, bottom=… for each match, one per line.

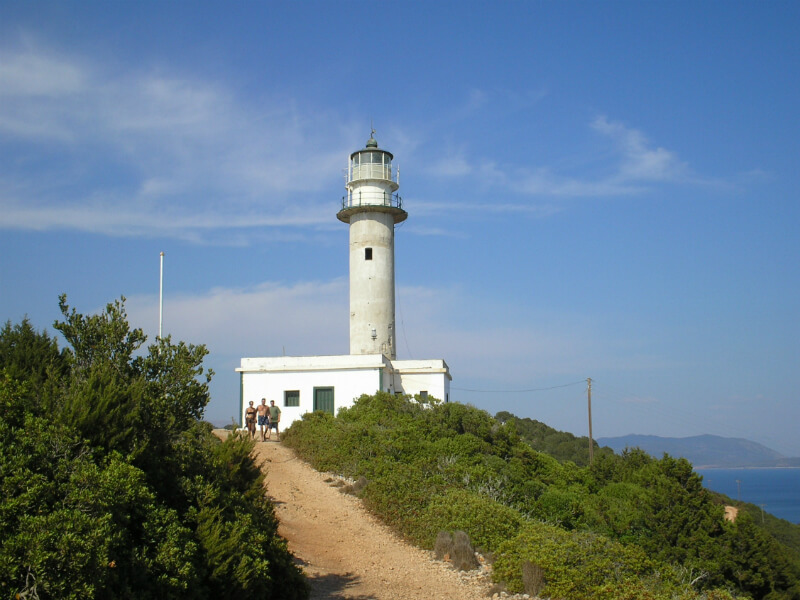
left=284, top=393, right=800, bottom=600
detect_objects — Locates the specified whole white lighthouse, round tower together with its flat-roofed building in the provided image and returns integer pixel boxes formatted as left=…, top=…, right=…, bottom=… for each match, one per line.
left=236, top=131, right=452, bottom=428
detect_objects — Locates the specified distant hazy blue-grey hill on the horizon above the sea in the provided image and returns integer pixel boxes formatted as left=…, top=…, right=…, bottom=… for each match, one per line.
left=597, top=435, right=800, bottom=468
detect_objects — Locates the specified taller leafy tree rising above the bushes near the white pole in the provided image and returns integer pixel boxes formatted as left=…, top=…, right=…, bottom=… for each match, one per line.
left=51, top=295, right=213, bottom=472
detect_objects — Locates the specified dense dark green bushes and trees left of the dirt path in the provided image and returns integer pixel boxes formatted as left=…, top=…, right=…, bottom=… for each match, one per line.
left=0, top=297, right=308, bottom=600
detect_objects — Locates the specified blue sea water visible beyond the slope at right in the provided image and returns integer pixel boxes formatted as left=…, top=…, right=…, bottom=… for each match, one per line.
left=695, top=468, right=800, bottom=524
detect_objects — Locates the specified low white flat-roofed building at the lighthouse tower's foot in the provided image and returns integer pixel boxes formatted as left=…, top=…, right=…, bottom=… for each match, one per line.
left=236, top=354, right=452, bottom=429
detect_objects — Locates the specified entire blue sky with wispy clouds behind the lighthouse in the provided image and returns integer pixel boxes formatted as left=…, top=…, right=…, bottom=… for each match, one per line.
left=0, top=1, right=800, bottom=456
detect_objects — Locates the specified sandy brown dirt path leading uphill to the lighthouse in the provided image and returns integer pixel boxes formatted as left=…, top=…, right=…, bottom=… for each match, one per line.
left=255, top=441, right=490, bottom=600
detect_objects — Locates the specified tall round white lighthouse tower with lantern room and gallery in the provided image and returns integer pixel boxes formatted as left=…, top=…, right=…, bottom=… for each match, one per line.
left=336, top=129, right=408, bottom=359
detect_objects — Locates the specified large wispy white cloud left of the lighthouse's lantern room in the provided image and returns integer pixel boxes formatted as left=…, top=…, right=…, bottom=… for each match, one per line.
left=0, top=44, right=356, bottom=239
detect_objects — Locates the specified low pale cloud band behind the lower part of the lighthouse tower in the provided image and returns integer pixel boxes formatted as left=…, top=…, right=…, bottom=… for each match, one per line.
left=119, top=278, right=672, bottom=420
